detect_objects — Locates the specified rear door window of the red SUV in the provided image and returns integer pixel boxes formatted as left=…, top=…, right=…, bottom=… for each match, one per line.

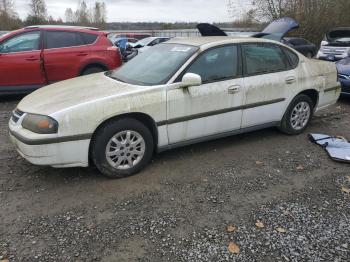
left=45, top=31, right=85, bottom=49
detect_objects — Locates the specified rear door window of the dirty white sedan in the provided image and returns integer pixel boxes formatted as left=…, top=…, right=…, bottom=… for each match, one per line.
left=243, top=44, right=288, bottom=75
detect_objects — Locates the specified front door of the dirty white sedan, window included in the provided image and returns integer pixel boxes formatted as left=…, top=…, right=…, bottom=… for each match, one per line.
left=167, top=45, right=244, bottom=144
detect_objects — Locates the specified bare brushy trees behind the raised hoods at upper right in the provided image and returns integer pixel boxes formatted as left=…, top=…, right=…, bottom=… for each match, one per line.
left=228, top=0, right=350, bottom=44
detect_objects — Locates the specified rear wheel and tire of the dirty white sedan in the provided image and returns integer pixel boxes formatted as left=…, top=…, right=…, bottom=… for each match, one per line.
left=279, top=94, right=314, bottom=135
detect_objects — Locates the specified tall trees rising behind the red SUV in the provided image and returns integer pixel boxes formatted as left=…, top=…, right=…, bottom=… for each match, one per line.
left=0, top=0, right=107, bottom=31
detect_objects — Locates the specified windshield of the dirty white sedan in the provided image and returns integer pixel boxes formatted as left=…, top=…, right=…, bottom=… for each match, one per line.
left=110, top=44, right=198, bottom=86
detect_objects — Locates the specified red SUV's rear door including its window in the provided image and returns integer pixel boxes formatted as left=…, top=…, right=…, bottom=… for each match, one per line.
left=44, top=30, right=90, bottom=83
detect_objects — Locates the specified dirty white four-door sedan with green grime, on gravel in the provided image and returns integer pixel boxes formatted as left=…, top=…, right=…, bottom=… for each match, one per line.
left=9, top=37, right=340, bottom=177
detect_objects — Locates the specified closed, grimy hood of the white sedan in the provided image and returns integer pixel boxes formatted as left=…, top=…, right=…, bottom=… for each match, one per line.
left=18, top=73, right=140, bottom=115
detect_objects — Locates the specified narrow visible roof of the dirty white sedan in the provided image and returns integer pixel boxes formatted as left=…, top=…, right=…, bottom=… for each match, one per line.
left=166, top=36, right=280, bottom=47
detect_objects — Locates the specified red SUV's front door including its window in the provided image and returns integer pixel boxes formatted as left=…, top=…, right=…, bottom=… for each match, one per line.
left=0, top=30, right=46, bottom=91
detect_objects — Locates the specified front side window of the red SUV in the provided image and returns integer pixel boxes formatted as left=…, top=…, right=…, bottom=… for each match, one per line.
left=0, top=31, right=40, bottom=53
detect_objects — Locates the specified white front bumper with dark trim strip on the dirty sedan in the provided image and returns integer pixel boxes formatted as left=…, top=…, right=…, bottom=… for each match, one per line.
left=9, top=120, right=90, bottom=167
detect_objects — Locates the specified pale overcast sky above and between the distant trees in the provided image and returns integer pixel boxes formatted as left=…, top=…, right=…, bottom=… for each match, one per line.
left=14, top=0, right=249, bottom=23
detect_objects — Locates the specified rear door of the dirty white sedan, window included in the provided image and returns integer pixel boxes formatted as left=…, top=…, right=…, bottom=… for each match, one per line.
left=242, top=43, right=298, bottom=128
